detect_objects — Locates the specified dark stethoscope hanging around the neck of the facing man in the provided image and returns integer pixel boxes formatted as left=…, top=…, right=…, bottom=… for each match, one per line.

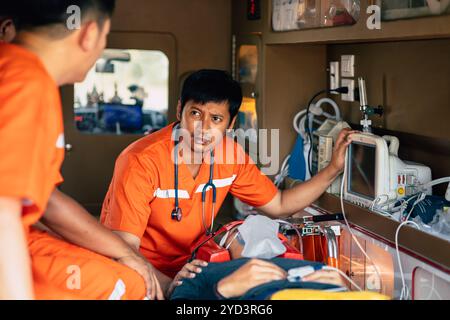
left=171, top=139, right=217, bottom=235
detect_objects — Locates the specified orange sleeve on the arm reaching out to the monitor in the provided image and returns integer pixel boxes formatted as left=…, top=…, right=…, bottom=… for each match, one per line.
left=230, top=145, right=278, bottom=207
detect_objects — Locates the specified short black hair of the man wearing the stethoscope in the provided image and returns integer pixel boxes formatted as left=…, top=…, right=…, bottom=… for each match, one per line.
left=180, top=69, right=242, bottom=121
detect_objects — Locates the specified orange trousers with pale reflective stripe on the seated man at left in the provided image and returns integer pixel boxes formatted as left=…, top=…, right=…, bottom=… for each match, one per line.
left=28, top=228, right=146, bottom=300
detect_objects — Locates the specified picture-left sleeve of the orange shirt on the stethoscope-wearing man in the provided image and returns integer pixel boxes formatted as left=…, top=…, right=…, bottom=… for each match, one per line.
left=102, top=154, right=156, bottom=238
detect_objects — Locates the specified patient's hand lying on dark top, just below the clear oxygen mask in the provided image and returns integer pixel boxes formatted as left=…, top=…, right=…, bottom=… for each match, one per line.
left=217, top=259, right=287, bottom=298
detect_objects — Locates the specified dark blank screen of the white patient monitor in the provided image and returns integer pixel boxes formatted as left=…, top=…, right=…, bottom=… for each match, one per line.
left=347, top=142, right=376, bottom=200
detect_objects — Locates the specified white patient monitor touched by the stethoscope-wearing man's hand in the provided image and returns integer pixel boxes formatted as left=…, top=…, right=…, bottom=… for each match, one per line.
left=344, top=133, right=431, bottom=209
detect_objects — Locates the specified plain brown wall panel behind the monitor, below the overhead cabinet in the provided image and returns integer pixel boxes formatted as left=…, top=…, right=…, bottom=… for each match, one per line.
left=328, top=39, right=450, bottom=140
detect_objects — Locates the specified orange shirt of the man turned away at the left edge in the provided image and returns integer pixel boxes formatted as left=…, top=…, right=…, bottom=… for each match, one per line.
left=0, top=44, right=64, bottom=229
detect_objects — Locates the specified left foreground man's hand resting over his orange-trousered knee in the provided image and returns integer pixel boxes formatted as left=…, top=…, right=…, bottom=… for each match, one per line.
left=117, top=254, right=164, bottom=300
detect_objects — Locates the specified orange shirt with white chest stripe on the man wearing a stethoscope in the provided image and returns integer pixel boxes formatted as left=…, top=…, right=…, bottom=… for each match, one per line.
left=101, top=124, right=278, bottom=277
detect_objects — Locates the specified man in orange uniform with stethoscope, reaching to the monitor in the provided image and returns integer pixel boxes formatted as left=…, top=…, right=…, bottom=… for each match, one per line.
left=101, top=70, right=358, bottom=294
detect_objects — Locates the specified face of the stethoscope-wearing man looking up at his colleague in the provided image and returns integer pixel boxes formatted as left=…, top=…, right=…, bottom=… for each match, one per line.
left=178, top=101, right=235, bottom=153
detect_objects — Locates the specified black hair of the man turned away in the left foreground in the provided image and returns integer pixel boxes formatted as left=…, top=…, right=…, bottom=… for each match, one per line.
left=0, top=0, right=116, bottom=30
